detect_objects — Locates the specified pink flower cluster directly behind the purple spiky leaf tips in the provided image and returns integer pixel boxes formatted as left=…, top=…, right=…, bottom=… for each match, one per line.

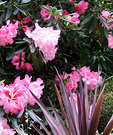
left=55, top=66, right=102, bottom=94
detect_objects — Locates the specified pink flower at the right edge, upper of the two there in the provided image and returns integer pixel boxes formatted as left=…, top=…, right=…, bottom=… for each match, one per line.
left=102, top=10, right=113, bottom=29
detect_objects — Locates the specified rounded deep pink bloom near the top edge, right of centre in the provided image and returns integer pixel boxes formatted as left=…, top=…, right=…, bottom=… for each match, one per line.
left=74, top=1, right=88, bottom=14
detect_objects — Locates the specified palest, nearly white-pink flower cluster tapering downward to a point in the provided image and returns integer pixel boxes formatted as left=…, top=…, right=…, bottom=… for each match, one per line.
left=25, top=22, right=60, bottom=62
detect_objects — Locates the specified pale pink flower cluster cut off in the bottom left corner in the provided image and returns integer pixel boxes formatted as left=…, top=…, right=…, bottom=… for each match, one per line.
left=0, top=117, right=16, bottom=135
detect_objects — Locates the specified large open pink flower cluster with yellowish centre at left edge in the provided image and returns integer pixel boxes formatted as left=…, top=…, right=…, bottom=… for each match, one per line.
left=0, top=75, right=44, bottom=114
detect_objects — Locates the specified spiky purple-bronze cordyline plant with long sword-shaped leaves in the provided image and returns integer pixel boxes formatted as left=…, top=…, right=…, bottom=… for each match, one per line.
left=16, top=69, right=113, bottom=135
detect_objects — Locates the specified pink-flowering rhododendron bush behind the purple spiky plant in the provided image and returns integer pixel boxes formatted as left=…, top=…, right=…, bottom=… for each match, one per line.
left=0, top=0, right=113, bottom=134
